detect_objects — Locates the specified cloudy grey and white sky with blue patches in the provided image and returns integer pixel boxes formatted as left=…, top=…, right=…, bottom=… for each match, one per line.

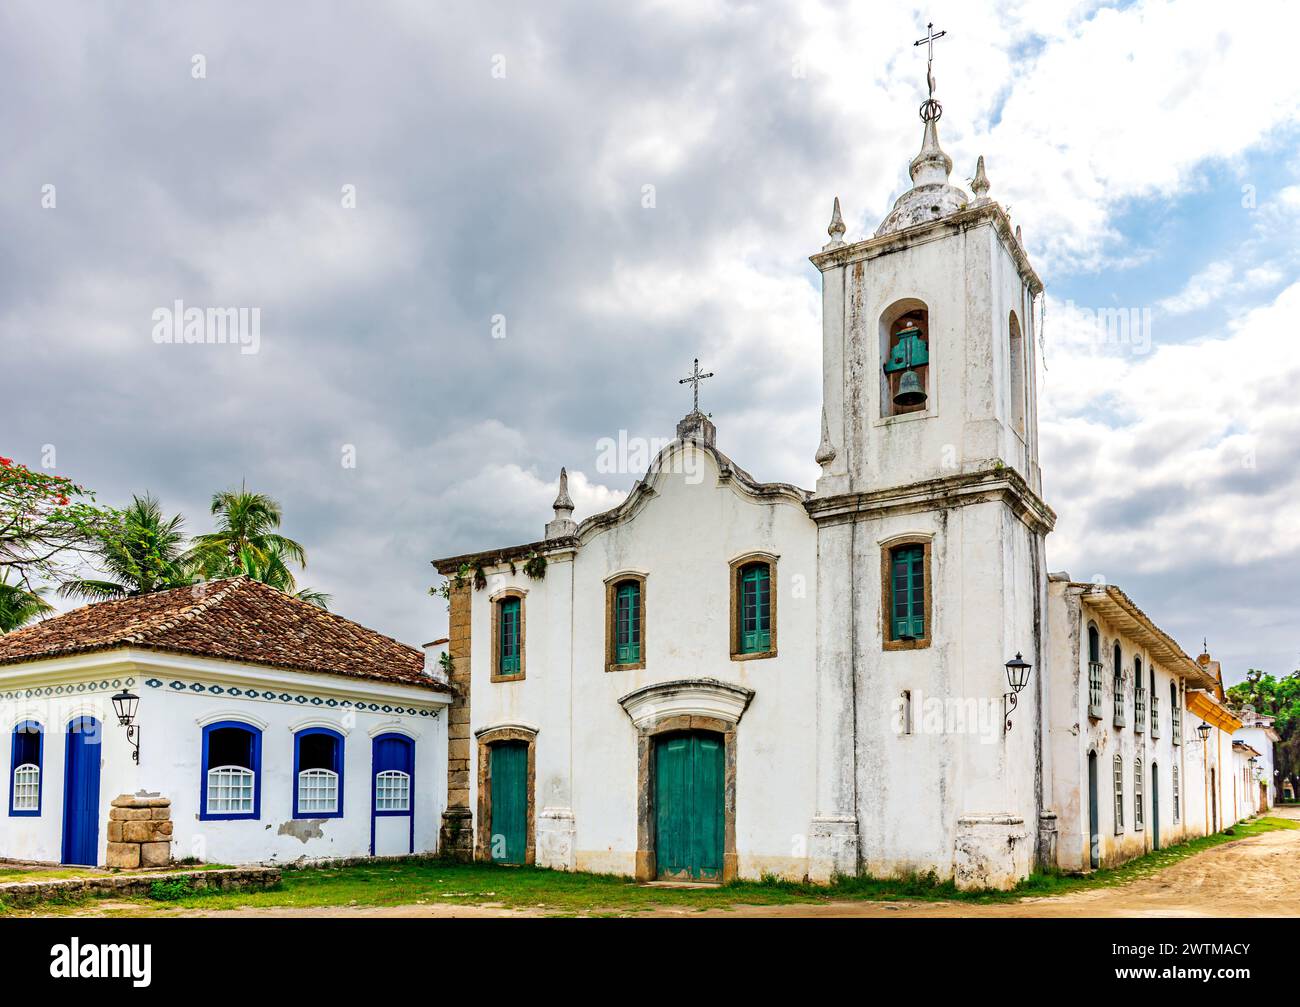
left=0, top=0, right=1300, bottom=680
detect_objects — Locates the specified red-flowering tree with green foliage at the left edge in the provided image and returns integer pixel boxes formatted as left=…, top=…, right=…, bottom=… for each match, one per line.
left=0, top=456, right=120, bottom=593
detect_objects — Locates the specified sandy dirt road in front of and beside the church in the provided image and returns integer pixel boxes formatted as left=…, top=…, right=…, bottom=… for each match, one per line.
left=162, top=807, right=1300, bottom=919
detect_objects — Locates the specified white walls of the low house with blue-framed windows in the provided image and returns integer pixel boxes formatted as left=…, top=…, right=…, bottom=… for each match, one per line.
left=0, top=651, right=447, bottom=864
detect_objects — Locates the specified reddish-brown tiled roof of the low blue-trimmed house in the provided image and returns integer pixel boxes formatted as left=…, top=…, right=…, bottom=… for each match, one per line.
left=0, top=577, right=449, bottom=691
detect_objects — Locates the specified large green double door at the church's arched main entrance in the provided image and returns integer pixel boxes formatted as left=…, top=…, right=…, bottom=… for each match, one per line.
left=655, top=734, right=723, bottom=881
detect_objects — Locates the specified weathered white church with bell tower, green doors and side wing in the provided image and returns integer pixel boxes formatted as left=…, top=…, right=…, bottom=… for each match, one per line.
left=436, top=88, right=1263, bottom=887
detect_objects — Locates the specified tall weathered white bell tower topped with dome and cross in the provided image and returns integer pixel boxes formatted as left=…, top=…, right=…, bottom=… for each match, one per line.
left=807, top=26, right=1056, bottom=886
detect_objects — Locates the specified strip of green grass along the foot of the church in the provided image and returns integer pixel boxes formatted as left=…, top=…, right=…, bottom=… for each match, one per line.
left=61, top=819, right=1300, bottom=915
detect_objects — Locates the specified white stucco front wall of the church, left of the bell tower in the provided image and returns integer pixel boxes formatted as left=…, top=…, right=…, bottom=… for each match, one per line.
left=471, top=443, right=816, bottom=877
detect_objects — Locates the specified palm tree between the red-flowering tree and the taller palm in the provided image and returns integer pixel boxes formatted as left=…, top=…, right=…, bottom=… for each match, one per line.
left=59, top=494, right=195, bottom=602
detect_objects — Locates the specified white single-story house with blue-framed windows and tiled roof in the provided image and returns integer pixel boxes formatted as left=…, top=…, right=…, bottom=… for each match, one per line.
left=0, top=577, right=452, bottom=865
